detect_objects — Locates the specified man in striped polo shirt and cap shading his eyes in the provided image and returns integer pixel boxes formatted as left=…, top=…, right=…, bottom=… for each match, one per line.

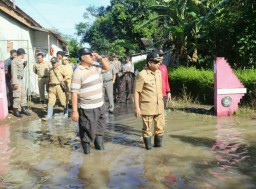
left=71, top=48, right=109, bottom=154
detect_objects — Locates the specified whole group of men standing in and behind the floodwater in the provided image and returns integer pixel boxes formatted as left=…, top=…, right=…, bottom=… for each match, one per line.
left=5, top=48, right=171, bottom=154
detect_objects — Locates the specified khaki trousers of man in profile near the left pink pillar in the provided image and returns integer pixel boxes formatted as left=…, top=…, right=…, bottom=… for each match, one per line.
left=12, top=79, right=27, bottom=108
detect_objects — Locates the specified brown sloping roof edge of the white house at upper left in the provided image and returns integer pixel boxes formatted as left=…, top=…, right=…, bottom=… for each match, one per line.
left=0, top=0, right=67, bottom=44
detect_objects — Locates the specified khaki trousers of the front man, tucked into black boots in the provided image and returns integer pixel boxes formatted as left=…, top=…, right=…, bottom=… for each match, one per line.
left=142, top=113, right=165, bottom=137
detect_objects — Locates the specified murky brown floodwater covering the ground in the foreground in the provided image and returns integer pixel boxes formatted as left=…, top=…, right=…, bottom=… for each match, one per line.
left=0, top=104, right=256, bottom=189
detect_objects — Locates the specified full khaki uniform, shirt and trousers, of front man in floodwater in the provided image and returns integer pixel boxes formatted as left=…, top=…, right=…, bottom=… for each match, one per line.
left=134, top=70, right=165, bottom=137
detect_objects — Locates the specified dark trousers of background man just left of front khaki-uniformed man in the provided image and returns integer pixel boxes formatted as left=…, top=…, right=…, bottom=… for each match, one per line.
left=119, top=74, right=132, bottom=100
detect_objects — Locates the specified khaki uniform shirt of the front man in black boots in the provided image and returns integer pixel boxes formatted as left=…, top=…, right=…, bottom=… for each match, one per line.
left=134, top=70, right=164, bottom=115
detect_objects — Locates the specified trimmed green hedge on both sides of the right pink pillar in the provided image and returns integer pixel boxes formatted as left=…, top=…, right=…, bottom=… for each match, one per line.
left=169, top=67, right=256, bottom=107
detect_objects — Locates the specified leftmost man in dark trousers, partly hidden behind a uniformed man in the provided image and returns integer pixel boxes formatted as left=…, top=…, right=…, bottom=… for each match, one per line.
left=4, top=49, right=17, bottom=111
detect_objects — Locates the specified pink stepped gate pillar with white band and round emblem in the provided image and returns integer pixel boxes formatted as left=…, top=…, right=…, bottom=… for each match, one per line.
left=214, top=57, right=246, bottom=116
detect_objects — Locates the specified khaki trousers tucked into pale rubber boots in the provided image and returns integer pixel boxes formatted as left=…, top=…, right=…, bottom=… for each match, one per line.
left=48, top=85, right=66, bottom=106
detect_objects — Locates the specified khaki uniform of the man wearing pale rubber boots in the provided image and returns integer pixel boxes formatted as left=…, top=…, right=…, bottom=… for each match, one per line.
left=48, top=66, right=67, bottom=106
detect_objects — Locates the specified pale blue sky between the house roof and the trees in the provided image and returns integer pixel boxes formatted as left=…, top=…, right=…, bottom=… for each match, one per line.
left=16, top=0, right=110, bottom=36
